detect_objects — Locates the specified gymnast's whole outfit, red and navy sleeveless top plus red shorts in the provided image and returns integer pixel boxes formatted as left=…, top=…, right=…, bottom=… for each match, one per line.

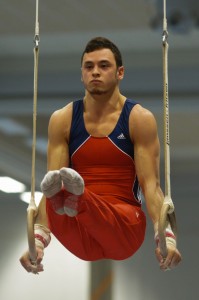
left=47, top=99, right=146, bottom=261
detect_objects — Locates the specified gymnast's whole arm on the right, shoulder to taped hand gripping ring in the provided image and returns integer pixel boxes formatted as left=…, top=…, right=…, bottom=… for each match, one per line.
left=129, top=105, right=181, bottom=270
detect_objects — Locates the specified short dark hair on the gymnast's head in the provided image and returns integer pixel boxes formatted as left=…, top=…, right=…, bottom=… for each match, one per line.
left=81, top=37, right=123, bottom=67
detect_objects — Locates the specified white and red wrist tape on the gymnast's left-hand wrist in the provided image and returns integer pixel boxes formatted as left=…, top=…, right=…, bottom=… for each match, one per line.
left=34, top=224, right=51, bottom=249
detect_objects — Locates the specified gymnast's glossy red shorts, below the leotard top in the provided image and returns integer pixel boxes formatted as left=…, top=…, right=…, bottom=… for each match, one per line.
left=46, top=188, right=146, bottom=261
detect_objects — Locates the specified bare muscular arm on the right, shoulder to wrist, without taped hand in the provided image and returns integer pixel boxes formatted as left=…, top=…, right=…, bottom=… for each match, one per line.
left=131, top=105, right=164, bottom=224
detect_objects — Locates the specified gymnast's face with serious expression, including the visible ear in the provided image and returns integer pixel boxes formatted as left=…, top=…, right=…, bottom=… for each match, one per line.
left=82, top=49, right=124, bottom=95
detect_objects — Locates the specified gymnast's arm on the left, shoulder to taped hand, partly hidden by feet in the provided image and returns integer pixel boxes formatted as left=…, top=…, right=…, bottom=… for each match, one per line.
left=20, top=104, right=72, bottom=274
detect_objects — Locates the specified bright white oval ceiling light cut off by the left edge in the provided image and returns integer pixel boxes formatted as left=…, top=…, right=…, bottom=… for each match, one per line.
left=0, top=176, right=26, bottom=193
